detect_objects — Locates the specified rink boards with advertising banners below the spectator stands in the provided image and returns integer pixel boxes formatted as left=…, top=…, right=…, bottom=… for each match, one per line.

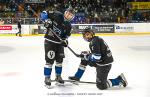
left=0, top=23, right=150, bottom=35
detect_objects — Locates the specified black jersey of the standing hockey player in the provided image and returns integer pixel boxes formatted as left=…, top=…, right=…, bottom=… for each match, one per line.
left=45, top=11, right=71, bottom=42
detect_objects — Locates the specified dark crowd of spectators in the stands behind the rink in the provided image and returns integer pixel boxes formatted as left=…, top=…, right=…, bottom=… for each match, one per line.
left=0, top=0, right=150, bottom=24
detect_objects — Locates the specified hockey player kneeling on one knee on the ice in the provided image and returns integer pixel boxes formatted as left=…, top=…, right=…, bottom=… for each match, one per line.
left=69, top=28, right=127, bottom=90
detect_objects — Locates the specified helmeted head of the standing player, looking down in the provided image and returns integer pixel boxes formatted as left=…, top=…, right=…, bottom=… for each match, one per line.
left=64, top=7, right=75, bottom=21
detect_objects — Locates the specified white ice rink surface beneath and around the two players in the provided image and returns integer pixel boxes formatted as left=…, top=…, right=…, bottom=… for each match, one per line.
left=0, top=35, right=150, bottom=97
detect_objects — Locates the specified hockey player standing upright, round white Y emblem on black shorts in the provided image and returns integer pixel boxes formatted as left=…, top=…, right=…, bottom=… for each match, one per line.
left=40, top=8, right=74, bottom=86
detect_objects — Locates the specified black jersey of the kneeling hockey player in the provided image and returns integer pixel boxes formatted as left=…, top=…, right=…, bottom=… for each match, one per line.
left=89, top=36, right=113, bottom=64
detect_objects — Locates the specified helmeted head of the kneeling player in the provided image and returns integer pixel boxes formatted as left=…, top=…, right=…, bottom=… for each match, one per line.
left=82, top=27, right=95, bottom=42
